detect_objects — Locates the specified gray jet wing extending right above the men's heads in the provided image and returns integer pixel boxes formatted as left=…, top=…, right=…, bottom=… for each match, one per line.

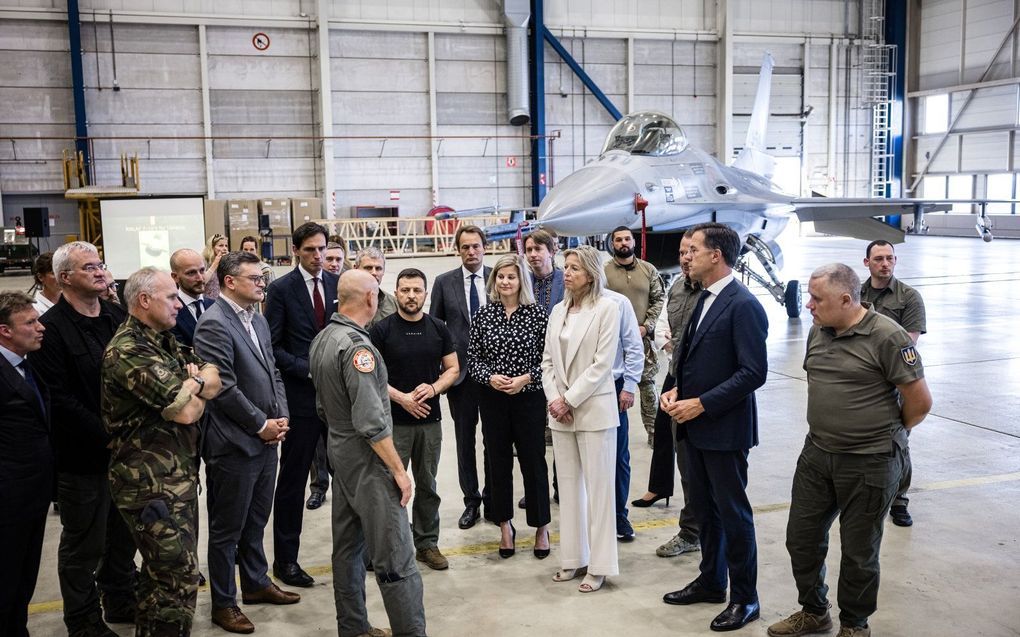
left=792, top=197, right=952, bottom=244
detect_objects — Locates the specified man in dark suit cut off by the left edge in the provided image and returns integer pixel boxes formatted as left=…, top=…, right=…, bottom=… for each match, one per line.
left=0, top=291, right=54, bottom=637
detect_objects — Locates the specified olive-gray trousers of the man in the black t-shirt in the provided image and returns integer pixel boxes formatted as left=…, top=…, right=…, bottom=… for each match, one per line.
left=393, top=422, right=443, bottom=548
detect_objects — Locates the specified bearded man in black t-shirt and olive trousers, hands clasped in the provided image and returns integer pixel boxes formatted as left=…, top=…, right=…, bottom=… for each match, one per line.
left=369, top=268, right=460, bottom=571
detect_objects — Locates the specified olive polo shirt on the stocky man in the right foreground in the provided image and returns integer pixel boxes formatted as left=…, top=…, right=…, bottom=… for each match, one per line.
left=804, top=304, right=924, bottom=454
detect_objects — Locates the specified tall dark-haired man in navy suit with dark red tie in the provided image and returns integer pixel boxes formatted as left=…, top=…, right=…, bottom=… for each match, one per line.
left=265, top=223, right=339, bottom=586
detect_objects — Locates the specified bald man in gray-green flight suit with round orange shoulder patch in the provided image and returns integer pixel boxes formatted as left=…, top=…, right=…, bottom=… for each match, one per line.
left=308, top=270, right=425, bottom=637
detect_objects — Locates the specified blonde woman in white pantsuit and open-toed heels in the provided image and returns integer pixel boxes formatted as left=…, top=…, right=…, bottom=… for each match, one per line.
left=542, top=246, right=620, bottom=593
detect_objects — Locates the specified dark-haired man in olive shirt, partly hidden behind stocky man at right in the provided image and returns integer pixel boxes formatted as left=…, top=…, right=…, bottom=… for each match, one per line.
left=861, top=240, right=927, bottom=526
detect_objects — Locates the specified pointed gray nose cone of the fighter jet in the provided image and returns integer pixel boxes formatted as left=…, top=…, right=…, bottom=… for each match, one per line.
left=539, top=165, right=639, bottom=235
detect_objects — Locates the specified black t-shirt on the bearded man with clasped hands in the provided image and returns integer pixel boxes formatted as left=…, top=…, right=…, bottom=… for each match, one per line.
left=368, top=313, right=455, bottom=425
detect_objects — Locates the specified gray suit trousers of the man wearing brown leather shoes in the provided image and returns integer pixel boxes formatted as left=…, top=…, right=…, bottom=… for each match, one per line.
left=205, top=446, right=277, bottom=608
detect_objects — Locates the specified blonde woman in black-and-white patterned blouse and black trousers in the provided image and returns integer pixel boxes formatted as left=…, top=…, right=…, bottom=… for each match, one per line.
left=467, top=255, right=552, bottom=560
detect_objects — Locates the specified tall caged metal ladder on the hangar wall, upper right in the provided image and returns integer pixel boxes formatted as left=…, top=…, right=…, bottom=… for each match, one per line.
left=861, top=0, right=897, bottom=197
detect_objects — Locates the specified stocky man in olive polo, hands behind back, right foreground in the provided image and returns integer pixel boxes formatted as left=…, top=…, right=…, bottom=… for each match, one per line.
left=768, top=263, right=931, bottom=637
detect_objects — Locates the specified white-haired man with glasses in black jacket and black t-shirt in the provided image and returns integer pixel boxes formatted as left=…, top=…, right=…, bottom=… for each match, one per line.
left=32, top=242, right=136, bottom=637
